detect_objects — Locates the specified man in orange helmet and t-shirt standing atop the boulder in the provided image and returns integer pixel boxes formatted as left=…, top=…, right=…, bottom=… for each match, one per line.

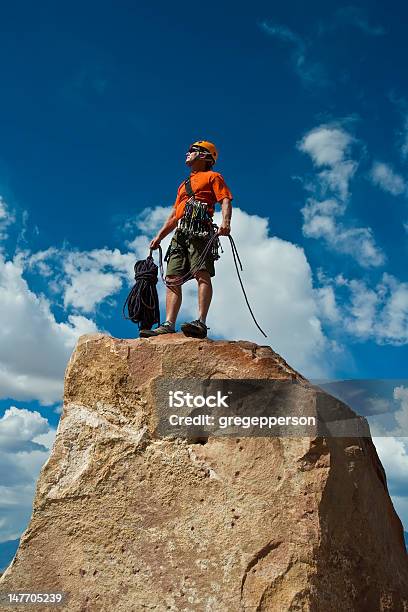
left=140, top=140, right=232, bottom=338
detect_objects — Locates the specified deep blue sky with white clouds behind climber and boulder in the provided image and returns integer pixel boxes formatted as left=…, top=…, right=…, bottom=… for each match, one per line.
left=0, top=1, right=408, bottom=560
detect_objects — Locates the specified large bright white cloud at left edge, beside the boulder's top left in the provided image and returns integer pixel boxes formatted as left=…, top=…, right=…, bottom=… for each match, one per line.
left=0, top=257, right=97, bottom=404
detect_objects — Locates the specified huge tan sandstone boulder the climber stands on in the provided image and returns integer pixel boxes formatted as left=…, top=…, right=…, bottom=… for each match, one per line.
left=0, top=334, right=408, bottom=612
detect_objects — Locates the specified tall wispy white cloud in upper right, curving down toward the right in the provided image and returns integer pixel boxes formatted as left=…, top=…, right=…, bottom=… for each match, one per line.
left=297, top=124, right=385, bottom=268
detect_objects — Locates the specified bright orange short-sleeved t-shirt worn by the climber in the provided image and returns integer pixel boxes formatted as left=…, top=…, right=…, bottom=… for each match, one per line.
left=174, top=170, right=232, bottom=219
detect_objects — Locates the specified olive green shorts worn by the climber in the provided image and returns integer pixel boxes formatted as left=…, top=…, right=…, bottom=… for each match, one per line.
left=166, top=230, right=215, bottom=276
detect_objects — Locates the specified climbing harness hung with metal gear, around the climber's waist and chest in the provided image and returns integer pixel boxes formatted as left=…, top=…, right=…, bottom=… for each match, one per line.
left=164, top=177, right=223, bottom=261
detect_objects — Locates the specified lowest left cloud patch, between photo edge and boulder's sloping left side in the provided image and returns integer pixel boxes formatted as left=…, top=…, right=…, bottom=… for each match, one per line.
left=0, top=406, right=56, bottom=542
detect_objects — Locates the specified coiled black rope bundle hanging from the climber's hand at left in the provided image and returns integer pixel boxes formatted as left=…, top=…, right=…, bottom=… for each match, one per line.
left=122, top=249, right=160, bottom=329
